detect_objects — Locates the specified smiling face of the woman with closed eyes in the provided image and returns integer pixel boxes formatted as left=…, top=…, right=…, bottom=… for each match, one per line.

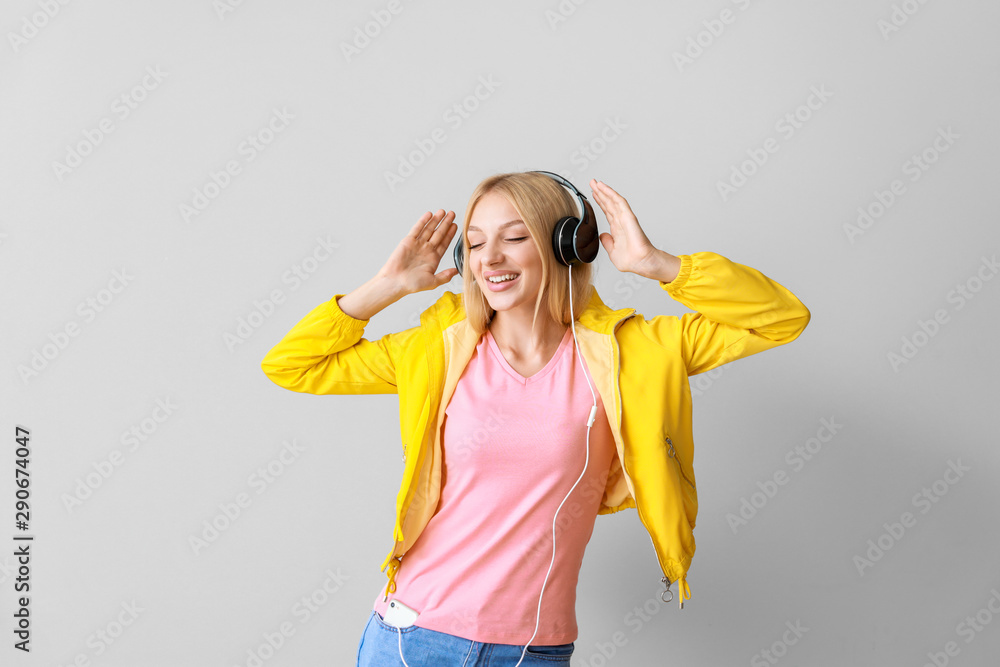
left=468, top=192, right=542, bottom=317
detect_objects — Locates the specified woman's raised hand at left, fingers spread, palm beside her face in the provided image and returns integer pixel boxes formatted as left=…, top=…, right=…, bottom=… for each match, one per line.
left=379, top=209, right=458, bottom=294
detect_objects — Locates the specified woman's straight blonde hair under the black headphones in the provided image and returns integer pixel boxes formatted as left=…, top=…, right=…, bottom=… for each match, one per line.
left=461, top=172, right=593, bottom=334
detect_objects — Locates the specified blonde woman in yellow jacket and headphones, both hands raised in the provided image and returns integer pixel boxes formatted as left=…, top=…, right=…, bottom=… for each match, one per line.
left=262, top=172, right=809, bottom=667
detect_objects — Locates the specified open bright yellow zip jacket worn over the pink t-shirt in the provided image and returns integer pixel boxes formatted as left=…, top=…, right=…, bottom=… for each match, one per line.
left=261, top=252, right=809, bottom=606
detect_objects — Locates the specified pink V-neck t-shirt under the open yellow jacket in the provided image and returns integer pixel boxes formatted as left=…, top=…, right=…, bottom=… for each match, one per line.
left=374, top=328, right=615, bottom=645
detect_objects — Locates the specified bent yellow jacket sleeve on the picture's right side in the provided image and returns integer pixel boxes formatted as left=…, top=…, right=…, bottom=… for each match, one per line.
left=646, top=252, right=810, bottom=375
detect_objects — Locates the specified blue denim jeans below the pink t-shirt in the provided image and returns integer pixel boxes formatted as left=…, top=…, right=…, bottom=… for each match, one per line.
left=358, top=609, right=574, bottom=667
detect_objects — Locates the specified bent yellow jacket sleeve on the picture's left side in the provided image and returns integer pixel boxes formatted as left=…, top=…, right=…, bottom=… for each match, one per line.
left=260, top=294, right=418, bottom=394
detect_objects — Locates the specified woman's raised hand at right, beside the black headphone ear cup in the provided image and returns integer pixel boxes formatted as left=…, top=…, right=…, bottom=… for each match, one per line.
left=590, top=179, right=660, bottom=277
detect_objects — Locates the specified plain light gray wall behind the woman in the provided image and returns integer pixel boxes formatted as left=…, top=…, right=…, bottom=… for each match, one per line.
left=0, top=0, right=1000, bottom=667
